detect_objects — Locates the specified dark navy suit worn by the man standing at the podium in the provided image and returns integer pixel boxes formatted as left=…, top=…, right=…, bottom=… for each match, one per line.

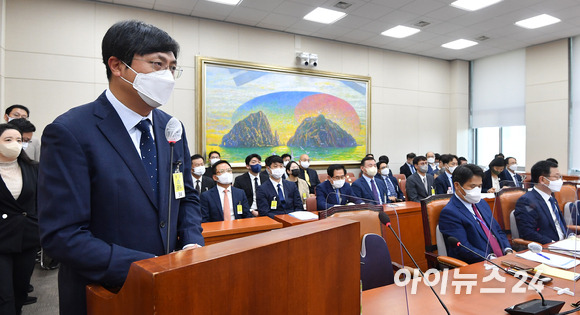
left=38, top=93, right=204, bottom=314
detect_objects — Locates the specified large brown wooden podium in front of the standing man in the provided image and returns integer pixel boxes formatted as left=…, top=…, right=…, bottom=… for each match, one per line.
left=87, top=218, right=360, bottom=315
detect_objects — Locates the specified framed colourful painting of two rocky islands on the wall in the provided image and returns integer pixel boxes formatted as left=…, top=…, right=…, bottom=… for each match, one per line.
left=196, top=56, right=371, bottom=167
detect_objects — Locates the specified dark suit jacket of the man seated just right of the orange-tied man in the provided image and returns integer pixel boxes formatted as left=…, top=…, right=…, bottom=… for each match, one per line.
left=256, top=179, right=304, bottom=218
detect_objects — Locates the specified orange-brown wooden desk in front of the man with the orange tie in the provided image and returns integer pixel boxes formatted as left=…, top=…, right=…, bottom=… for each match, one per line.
left=201, top=217, right=282, bottom=246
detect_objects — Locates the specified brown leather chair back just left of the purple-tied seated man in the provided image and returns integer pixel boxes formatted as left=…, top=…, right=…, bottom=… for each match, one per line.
left=421, top=194, right=453, bottom=268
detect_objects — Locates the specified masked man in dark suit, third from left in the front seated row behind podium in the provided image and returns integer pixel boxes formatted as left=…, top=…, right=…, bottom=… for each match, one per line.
left=316, top=164, right=361, bottom=211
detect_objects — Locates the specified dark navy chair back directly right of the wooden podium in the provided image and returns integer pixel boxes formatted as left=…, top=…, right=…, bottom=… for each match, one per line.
left=360, top=233, right=395, bottom=291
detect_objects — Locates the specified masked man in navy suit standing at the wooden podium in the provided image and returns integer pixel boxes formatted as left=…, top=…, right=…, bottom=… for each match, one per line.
left=38, top=21, right=204, bottom=315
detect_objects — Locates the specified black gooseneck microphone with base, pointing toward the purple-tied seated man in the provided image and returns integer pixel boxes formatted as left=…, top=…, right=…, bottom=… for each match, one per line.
left=447, top=236, right=564, bottom=315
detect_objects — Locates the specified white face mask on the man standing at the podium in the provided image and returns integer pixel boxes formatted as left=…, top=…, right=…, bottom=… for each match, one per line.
left=121, top=62, right=175, bottom=108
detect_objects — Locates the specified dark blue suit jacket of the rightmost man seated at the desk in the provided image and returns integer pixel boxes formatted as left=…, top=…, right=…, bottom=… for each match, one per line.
left=514, top=189, right=567, bottom=244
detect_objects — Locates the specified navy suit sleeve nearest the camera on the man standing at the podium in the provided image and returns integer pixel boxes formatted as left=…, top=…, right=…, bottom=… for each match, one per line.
left=38, top=123, right=154, bottom=285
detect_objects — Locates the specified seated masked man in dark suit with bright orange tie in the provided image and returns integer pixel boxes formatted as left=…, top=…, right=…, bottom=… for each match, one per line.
left=200, top=160, right=254, bottom=222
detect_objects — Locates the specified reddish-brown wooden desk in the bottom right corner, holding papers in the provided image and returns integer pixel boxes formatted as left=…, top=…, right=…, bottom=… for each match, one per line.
left=362, top=255, right=580, bottom=315
